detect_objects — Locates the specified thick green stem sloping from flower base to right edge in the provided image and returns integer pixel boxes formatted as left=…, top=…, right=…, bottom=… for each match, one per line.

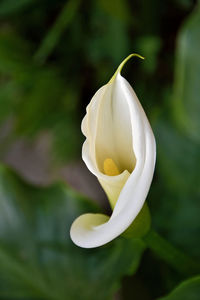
left=144, top=230, right=200, bottom=276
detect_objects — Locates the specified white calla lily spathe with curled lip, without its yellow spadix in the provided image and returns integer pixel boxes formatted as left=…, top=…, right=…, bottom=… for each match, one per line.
left=70, top=54, right=156, bottom=248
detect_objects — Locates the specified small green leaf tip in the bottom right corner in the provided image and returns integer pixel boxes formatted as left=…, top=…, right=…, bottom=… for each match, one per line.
left=159, top=276, right=200, bottom=300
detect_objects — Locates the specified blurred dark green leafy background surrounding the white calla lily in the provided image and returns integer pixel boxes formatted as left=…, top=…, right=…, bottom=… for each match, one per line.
left=0, top=0, right=200, bottom=300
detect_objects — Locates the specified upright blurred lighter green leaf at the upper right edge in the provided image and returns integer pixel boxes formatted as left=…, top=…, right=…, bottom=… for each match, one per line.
left=173, top=5, right=200, bottom=142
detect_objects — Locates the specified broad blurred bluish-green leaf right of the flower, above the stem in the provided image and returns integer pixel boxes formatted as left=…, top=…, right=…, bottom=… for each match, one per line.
left=152, top=117, right=200, bottom=257
